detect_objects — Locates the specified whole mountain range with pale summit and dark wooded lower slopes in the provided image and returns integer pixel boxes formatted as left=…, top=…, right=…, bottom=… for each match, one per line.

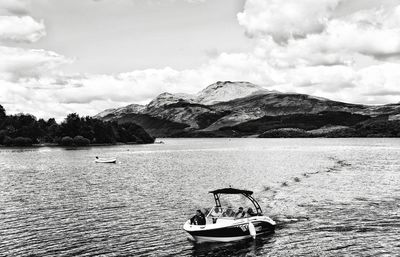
left=94, top=81, right=400, bottom=137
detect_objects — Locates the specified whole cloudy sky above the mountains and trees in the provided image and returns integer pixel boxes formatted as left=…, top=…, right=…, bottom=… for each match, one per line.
left=0, top=0, right=400, bottom=119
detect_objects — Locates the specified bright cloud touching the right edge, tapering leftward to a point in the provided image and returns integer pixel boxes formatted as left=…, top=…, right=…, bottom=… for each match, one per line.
left=300, top=6, right=400, bottom=58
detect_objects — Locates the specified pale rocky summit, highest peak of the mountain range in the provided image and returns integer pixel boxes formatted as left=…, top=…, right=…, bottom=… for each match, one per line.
left=196, top=81, right=270, bottom=105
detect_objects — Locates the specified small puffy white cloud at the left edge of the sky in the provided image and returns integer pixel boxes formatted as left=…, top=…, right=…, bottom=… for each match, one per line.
left=0, top=16, right=46, bottom=43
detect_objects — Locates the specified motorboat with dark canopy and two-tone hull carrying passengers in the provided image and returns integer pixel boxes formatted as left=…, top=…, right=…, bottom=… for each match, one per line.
left=183, top=188, right=276, bottom=242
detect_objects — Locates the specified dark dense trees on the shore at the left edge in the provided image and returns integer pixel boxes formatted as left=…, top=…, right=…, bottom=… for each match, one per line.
left=0, top=105, right=154, bottom=146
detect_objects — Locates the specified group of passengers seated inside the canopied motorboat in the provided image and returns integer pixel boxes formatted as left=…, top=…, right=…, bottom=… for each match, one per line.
left=190, top=207, right=257, bottom=225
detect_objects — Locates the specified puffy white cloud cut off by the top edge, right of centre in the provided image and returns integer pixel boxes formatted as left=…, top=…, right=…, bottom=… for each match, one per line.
left=237, top=0, right=340, bottom=43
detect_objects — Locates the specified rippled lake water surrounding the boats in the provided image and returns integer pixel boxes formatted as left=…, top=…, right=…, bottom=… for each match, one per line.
left=0, top=139, right=400, bottom=256
